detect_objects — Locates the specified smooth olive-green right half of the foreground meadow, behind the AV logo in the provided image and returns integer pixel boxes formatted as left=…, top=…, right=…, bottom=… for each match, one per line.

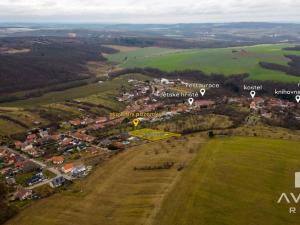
left=153, top=137, right=300, bottom=225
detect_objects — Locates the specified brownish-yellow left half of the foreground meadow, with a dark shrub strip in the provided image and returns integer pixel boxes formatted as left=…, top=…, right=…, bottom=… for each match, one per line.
left=7, top=134, right=204, bottom=225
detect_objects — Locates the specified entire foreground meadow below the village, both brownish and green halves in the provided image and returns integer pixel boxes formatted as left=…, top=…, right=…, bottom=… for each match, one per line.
left=7, top=134, right=300, bottom=225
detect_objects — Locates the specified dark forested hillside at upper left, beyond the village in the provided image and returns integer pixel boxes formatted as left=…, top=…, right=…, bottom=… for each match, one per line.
left=0, top=38, right=115, bottom=94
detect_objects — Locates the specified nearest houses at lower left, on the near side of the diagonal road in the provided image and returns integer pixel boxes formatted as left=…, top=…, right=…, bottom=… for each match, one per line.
left=0, top=144, right=92, bottom=201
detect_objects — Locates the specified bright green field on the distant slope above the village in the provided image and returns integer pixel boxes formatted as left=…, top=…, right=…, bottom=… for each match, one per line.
left=108, top=44, right=300, bottom=82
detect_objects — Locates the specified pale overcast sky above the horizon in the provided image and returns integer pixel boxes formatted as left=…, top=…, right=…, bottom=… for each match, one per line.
left=0, top=0, right=300, bottom=23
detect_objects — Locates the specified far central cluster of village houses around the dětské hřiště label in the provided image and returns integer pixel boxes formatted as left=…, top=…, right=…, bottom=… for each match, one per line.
left=111, top=78, right=216, bottom=125
